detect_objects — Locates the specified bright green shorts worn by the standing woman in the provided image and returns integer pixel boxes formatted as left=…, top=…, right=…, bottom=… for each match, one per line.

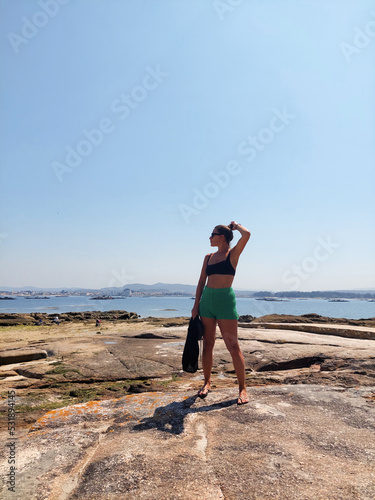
left=199, top=286, right=238, bottom=319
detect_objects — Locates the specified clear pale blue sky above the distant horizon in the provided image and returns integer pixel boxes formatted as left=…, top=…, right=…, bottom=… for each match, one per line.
left=0, top=0, right=375, bottom=291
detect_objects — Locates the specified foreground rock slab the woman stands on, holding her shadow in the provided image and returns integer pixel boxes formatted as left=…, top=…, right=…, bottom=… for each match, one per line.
left=0, top=385, right=375, bottom=500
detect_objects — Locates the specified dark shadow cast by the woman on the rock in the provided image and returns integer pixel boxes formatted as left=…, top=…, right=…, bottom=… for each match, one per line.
left=132, top=395, right=237, bottom=435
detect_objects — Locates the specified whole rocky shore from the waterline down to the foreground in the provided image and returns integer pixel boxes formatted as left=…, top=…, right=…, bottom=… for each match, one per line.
left=0, top=311, right=375, bottom=500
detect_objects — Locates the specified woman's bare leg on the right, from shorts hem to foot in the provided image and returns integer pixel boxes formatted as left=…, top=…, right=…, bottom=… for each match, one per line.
left=218, top=319, right=249, bottom=404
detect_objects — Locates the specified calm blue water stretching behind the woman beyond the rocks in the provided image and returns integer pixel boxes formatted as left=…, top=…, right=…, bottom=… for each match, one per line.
left=0, top=297, right=375, bottom=319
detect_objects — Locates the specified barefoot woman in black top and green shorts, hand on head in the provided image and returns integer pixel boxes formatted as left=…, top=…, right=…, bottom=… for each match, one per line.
left=191, top=221, right=250, bottom=405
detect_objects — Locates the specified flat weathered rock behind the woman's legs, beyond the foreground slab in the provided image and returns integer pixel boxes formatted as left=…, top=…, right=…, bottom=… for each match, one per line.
left=0, top=324, right=375, bottom=387
